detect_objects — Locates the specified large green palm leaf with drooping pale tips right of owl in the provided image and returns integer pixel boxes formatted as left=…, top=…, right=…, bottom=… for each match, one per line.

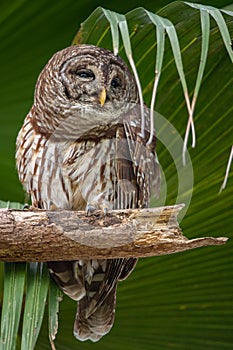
left=0, top=0, right=233, bottom=350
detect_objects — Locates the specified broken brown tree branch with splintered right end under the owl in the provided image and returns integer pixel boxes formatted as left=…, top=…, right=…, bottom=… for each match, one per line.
left=0, top=205, right=227, bottom=261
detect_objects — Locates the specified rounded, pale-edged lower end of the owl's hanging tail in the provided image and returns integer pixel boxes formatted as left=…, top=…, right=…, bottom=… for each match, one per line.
left=74, top=284, right=117, bottom=342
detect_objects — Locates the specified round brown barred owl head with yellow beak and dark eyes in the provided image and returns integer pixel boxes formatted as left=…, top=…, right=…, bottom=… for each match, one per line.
left=33, top=45, right=138, bottom=137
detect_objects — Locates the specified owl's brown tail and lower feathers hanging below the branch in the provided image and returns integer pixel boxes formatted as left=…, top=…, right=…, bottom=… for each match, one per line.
left=48, top=258, right=137, bottom=342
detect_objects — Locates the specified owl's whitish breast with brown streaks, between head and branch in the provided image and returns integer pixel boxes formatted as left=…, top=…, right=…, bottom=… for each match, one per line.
left=17, top=114, right=138, bottom=210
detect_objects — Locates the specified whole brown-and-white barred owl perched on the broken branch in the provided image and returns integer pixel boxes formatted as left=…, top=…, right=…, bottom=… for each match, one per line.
left=16, top=45, right=159, bottom=341
